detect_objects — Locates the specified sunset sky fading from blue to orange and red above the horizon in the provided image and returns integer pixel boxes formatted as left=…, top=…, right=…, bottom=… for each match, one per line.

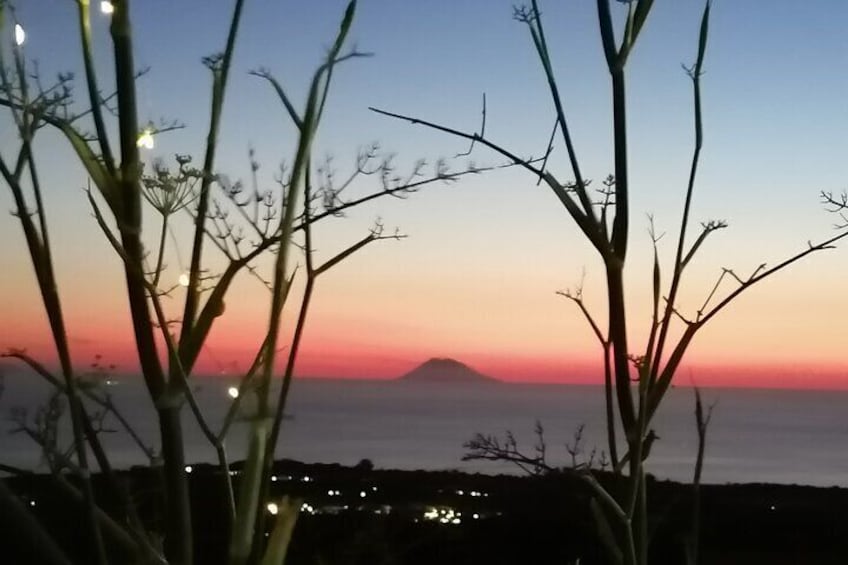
left=0, top=0, right=848, bottom=388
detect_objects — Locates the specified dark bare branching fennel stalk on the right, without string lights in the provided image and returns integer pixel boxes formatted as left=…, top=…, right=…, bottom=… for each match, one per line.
left=372, top=0, right=848, bottom=565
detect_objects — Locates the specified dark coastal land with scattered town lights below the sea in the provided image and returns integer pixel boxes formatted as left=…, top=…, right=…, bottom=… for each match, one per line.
left=0, top=461, right=848, bottom=565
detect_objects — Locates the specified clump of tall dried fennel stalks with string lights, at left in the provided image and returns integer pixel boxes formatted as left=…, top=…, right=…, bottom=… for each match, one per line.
left=0, top=0, right=491, bottom=564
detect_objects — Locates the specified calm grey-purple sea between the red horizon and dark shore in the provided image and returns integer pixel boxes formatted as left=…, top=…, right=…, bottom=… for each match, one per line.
left=0, top=373, right=848, bottom=486
